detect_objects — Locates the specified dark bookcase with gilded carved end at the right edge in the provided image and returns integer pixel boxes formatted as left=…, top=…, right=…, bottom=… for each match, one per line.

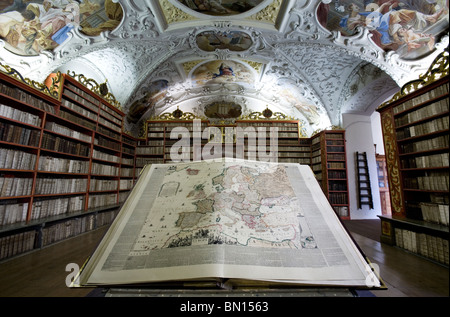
left=377, top=52, right=449, bottom=266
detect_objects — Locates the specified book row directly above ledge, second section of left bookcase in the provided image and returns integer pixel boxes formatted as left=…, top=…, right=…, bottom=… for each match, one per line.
left=31, top=195, right=86, bottom=220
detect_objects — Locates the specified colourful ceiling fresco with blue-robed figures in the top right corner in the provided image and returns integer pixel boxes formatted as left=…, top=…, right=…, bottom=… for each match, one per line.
left=317, top=0, right=448, bottom=59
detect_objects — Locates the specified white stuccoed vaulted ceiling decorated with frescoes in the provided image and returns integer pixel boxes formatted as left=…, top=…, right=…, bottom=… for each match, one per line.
left=0, top=0, right=448, bottom=135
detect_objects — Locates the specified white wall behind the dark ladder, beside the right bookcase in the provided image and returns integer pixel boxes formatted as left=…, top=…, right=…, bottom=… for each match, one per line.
left=342, top=114, right=384, bottom=219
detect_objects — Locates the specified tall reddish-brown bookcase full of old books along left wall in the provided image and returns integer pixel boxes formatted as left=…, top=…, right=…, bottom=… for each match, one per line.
left=0, top=64, right=137, bottom=260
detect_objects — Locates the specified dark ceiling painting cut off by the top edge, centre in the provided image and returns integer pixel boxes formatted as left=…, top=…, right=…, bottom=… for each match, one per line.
left=178, top=0, right=264, bottom=16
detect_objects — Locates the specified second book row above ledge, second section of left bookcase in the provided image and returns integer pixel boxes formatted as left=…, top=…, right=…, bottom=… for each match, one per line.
left=34, top=177, right=87, bottom=195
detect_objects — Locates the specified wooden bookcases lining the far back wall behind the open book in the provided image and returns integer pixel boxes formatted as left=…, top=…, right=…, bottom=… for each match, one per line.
left=144, top=110, right=350, bottom=219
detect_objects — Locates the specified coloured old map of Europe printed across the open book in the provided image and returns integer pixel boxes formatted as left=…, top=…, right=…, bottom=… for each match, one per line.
left=132, top=162, right=317, bottom=255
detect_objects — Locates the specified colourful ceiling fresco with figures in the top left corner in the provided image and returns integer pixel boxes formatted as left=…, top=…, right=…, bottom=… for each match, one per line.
left=0, top=0, right=123, bottom=55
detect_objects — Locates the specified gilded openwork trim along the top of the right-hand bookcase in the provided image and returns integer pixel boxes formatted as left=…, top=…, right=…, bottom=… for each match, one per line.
left=378, top=51, right=449, bottom=109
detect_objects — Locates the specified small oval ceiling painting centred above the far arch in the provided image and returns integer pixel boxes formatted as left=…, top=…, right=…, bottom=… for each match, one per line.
left=196, top=31, right=253, bottom=52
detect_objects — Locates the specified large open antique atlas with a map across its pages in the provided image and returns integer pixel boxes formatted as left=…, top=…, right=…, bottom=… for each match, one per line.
left=80, top=159, right=380, bottom=288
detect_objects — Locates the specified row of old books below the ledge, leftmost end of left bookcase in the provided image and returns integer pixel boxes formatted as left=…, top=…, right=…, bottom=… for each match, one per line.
left=0, top=230, right=37, bottom=260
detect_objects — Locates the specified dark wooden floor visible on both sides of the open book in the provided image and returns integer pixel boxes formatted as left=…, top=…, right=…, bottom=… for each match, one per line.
left=0, top=220, right=449, bottom=297
